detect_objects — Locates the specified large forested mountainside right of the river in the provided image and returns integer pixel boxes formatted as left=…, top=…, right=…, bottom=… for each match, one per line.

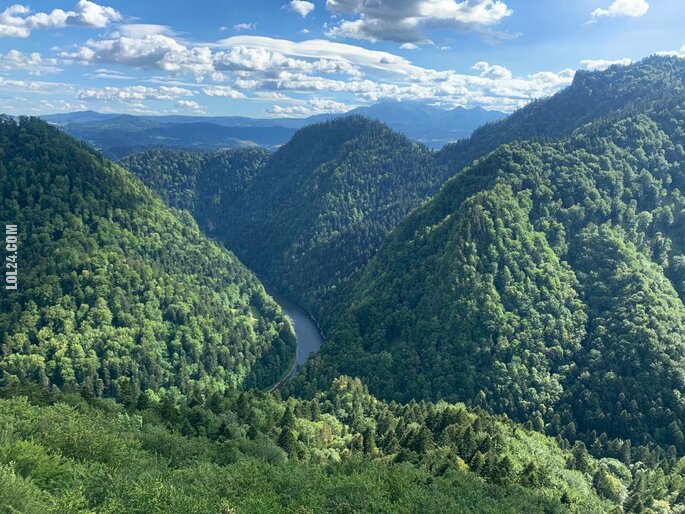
left=298, top=58, right=685, bottom=452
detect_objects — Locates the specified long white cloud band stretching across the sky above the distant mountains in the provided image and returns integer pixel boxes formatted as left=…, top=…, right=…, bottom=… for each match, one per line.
left=61, top=34, right=574, bottom=116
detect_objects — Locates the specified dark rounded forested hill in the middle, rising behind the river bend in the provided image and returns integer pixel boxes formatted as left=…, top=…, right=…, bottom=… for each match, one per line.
left=215, top=117, right=445, bottom=323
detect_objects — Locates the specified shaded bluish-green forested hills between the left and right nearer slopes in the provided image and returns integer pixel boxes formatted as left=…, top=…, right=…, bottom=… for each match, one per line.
left=121, top=116, right=446, bottom=325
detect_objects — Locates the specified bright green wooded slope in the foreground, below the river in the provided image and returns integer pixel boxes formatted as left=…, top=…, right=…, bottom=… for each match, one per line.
left=0, top=377, right=685, bottom=514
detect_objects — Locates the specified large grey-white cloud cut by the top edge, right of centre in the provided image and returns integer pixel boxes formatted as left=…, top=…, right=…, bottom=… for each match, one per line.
left=326, top=0, right=513, bottom=44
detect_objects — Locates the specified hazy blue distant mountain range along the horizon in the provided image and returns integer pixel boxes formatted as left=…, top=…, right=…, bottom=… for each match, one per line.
left=42, top=101, right=506, bottom=158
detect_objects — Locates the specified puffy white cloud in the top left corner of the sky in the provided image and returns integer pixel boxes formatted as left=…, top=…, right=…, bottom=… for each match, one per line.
left=0, top=0, right=122, bottom=38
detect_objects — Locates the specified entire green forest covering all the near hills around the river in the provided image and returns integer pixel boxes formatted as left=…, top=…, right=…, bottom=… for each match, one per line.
left=0, top=57, right=685, bottom=514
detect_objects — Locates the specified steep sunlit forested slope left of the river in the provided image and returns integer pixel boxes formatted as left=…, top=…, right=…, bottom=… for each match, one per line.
left=0, top=118, right=294, bottom=396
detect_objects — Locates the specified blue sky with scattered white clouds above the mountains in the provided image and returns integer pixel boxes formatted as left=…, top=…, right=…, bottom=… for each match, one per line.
left=0, top=0, right=685, bottom=117
